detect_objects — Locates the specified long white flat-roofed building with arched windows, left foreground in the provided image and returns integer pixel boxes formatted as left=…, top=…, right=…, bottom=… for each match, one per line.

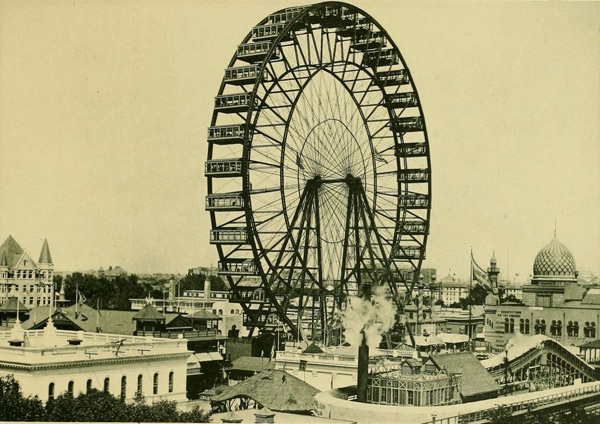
left=0, top=322, right=191, bottom=403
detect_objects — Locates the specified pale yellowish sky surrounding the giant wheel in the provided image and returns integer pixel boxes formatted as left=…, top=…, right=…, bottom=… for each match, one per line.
left=0, top=0, right=600, bottom=279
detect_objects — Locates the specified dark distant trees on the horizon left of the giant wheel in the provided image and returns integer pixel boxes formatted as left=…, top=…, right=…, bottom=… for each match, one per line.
left=54, top=272, right=228, bottom=310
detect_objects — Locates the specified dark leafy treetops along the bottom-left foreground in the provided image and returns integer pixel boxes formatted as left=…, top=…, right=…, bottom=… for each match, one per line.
left=0, top=375, right=210, bottom=423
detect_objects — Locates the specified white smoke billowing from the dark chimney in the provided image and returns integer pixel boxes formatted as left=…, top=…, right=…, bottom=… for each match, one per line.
left=342, top=286, right=396, bottom=348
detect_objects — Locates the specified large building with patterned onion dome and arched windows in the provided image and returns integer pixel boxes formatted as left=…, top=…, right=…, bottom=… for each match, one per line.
left=484, top=234, right=600, bottom=351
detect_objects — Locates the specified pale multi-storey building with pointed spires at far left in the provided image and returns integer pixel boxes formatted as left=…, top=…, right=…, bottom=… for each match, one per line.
left=0, top=236, right=54, bottom=309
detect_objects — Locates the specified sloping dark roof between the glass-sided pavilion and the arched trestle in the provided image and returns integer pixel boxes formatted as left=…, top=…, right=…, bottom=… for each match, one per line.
left=431, top=352, right=500, bottom=398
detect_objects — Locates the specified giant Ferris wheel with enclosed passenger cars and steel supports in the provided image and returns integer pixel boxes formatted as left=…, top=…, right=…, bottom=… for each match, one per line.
left=205, top=2, right=431, bottom=340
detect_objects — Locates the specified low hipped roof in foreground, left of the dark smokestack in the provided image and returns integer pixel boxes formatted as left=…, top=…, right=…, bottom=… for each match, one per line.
left=211, top=370, right=319, bottom=412
